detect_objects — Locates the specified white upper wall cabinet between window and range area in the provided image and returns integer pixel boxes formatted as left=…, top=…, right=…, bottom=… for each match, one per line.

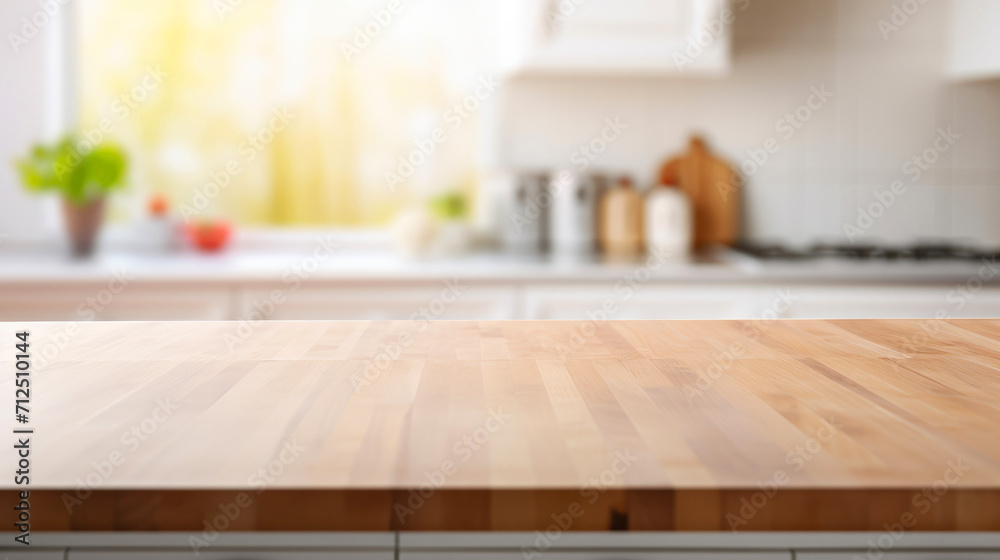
left=499, top=0, right=746, bottom=76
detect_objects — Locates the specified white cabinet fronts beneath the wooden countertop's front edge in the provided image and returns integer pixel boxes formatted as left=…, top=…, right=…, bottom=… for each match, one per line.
left=0, top=532, right=1000, bottom=560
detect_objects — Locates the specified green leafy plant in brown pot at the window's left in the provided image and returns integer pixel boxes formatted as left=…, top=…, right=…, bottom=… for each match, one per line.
left=16, top=135, right=127, bottom=257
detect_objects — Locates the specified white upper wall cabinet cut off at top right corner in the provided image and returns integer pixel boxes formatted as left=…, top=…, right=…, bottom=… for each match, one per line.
left=948, top=0, right=1000, bottom=80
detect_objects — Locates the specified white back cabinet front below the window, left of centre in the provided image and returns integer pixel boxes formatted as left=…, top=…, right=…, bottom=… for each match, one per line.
left=239, top=281, right=519, bottom=321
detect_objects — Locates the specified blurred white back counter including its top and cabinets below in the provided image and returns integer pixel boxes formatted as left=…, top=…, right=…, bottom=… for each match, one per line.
left=0, top=248, right=1000, bottom=321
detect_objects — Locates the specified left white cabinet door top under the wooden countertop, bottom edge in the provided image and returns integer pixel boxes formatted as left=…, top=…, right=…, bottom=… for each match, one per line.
left=67, top=550, right=393, bottom=560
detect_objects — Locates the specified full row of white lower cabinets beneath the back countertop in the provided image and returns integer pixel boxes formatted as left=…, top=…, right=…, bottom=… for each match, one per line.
left=0, top=279, right=1000, bottom=321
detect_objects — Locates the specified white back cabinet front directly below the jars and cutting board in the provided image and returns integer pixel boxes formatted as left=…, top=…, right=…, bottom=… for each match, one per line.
left=524, top=283, right=767, bottom=321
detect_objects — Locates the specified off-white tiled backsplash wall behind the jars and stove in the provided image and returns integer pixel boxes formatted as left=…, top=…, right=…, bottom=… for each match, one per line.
left=501, top=0, right=1000, bottom=244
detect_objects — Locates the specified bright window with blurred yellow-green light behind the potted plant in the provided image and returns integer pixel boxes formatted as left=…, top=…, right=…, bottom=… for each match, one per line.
left=76, top=0, right=495, bottom=227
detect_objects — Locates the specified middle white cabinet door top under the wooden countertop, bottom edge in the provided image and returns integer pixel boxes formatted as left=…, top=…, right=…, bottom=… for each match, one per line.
left=399, top=549, right=792, bottom=560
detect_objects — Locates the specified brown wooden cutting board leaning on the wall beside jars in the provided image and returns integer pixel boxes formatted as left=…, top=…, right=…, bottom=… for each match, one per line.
left=660, top=136, right=740, bottom=246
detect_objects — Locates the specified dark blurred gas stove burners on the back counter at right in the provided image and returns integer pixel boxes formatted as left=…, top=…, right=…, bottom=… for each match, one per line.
left=737, top=243, right=998, bottom=261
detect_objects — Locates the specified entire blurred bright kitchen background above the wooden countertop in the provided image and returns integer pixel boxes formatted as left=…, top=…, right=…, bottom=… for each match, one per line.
left=0, top=0, right=1000, bottom=322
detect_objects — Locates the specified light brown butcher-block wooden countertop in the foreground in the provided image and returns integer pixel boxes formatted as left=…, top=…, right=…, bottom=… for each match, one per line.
left=0, top=322, right=1000, bottom=530
